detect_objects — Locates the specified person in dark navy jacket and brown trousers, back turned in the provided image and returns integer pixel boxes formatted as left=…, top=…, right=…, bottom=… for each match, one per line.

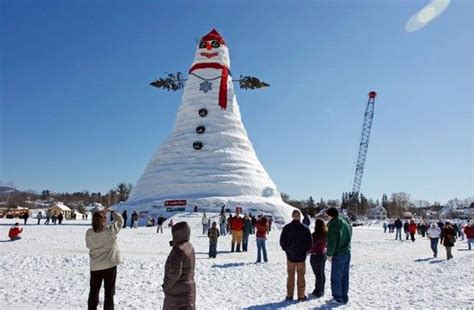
left=280, top=210, right=312, bottom=301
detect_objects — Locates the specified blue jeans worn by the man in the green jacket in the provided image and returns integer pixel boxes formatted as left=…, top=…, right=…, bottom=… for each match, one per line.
left=331, top=253, right=351, bottom=303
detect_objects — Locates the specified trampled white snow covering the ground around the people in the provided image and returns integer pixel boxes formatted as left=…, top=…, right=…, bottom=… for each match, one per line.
left=0, top=213, right=474, bottom=309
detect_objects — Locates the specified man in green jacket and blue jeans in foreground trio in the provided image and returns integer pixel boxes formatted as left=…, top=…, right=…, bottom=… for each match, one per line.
left=326, top=208, right=352, bottom=304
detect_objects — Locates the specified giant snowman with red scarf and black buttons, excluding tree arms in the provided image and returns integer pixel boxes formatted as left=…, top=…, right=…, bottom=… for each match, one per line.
left=114, top=29, right=294, bottom=224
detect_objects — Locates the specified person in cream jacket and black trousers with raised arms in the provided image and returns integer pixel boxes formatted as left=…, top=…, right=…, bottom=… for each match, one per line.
left=86, top=209, right=123, bottom=310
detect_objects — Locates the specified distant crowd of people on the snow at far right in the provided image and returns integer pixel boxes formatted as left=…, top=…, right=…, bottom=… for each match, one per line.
left=383, top=218, right=474, bottom=260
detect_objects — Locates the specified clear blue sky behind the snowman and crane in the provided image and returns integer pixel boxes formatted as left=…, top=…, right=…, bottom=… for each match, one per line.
left=0, top=0, right=474, bottom=202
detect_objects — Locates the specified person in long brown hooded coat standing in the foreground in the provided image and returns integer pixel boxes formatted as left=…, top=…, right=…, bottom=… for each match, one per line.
left=162, top=222, right=196, bottom=310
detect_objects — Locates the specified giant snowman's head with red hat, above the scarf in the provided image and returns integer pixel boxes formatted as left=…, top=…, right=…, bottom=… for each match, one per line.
left=193, top=29, right=230, bottom=68
